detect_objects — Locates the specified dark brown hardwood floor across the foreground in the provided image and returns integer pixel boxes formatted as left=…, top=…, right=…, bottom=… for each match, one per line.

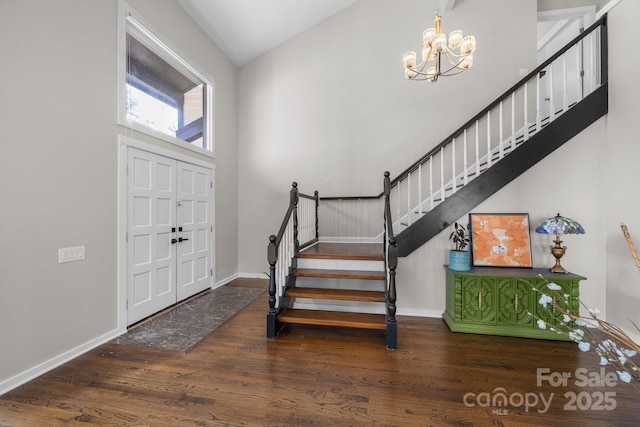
left=0, top=282, right=640, bottom=427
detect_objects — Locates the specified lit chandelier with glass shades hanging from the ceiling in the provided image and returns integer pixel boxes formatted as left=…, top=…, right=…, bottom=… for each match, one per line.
left=402, top=12, right=476, bottom=83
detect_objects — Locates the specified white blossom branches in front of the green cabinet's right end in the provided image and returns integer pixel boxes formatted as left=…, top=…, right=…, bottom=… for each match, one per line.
left=527, top=224, right=640, bottom=389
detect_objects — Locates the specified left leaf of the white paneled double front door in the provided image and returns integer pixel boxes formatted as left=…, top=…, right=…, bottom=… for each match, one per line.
left=127, top=149, right=176, bottom=325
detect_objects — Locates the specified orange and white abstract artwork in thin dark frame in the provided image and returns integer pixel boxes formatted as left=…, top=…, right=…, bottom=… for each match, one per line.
left=469, top=213, right=532, bottom=268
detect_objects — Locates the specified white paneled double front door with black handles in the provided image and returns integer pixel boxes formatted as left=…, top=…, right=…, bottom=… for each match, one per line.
left=127, top=147, right=213, bottom=325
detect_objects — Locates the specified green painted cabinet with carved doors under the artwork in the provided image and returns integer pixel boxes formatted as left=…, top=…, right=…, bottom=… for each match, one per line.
left=442, top=267, right=585, bottom=340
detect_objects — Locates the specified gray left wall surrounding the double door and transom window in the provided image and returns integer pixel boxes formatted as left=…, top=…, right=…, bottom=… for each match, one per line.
left=0, top=0, right=238, bottom=390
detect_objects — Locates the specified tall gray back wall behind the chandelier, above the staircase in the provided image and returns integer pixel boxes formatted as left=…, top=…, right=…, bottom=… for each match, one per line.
left=238, top=0, right=536, bottom=284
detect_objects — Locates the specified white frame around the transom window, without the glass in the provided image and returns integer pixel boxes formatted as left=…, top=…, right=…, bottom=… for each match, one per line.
left=118, top=0, right=215, bottom=157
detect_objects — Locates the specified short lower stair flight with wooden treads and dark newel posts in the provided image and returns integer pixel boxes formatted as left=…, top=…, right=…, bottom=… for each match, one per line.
left=267, top=186, right=397, bottom=350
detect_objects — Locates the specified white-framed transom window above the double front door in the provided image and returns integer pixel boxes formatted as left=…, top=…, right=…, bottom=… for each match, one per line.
left=118, top=1, right=214, bottom=156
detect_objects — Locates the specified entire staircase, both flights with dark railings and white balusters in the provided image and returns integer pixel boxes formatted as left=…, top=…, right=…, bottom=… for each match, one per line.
left=267, top=16, right=608, bottom=349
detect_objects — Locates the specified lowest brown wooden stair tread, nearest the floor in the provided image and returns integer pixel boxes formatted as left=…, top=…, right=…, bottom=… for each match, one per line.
left=278, top=308, right=387, bottom=330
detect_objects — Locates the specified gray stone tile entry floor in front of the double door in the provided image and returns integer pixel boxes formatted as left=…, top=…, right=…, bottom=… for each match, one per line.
left=111, top=286, right=266, bottom=352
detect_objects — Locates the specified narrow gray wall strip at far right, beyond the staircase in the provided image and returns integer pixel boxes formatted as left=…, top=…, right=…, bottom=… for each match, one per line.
left=604, top=0, right=640, bottom=339
